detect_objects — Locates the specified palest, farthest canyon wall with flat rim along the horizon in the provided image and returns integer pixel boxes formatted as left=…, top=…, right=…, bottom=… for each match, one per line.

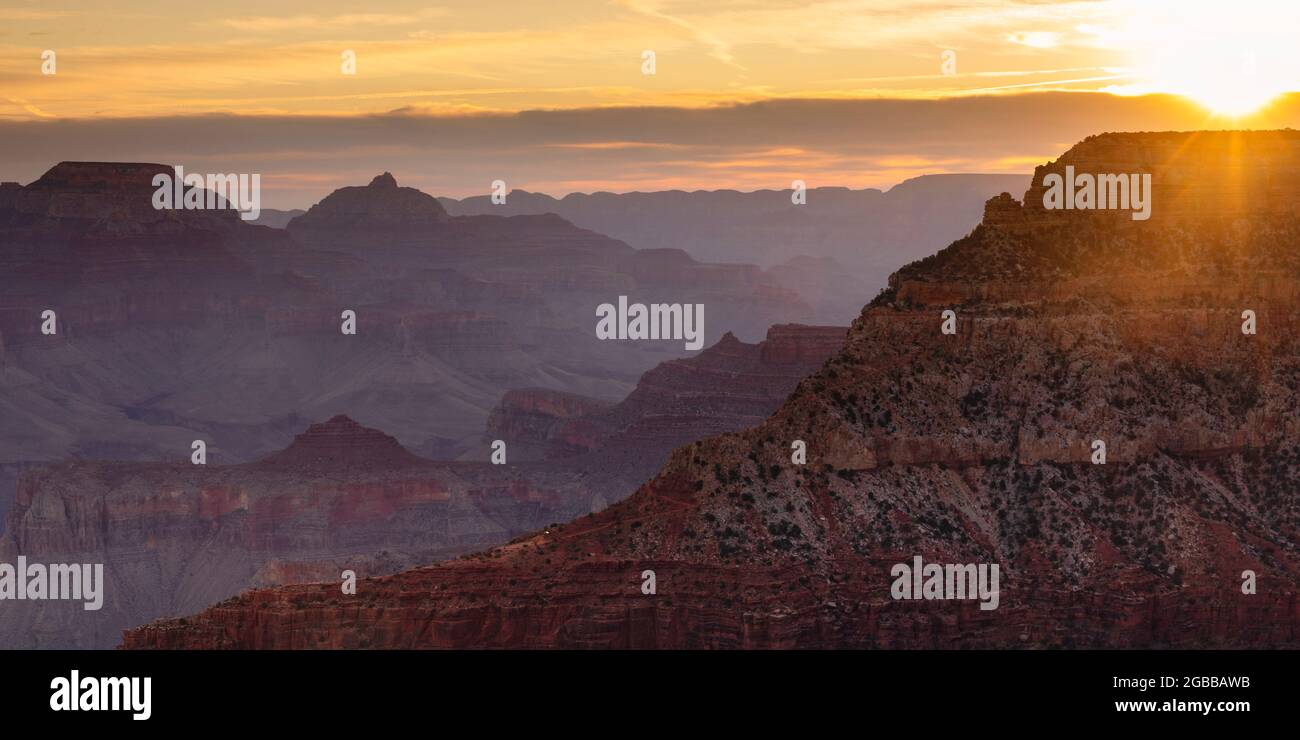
left=439, top=174, right=1030, bottom=325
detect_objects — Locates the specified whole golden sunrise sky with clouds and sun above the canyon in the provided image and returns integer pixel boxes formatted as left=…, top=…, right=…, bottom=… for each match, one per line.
left=0, top=0, right=1300, bottom=208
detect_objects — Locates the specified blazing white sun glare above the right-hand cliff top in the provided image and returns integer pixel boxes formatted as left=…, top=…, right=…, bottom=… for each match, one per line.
left=1115, top=0, right=1300, bottom=117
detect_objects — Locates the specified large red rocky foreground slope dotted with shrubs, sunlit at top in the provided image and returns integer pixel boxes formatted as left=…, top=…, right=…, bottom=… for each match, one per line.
left=124, top=131, right=1300, bottom=649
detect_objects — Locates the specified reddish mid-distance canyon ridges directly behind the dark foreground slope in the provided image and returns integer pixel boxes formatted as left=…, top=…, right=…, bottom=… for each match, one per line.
left=0, top=325, right=845, bottom=648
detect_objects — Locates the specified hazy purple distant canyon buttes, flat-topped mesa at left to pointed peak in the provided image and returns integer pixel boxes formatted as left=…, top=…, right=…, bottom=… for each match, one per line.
left=0, top=163, right=811, bottom=486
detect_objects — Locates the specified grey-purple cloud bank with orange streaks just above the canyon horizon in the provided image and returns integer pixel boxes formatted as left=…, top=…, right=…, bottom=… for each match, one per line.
left=0, top=92, right=1300, bottom=208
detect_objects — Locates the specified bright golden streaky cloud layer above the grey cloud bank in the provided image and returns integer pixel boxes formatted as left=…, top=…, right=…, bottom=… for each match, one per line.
left=0, top=0, right=1237, bottom=118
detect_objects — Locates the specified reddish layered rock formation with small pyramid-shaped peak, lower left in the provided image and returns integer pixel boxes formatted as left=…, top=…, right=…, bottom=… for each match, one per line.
left=0, top=416, right=579, bottom=648
